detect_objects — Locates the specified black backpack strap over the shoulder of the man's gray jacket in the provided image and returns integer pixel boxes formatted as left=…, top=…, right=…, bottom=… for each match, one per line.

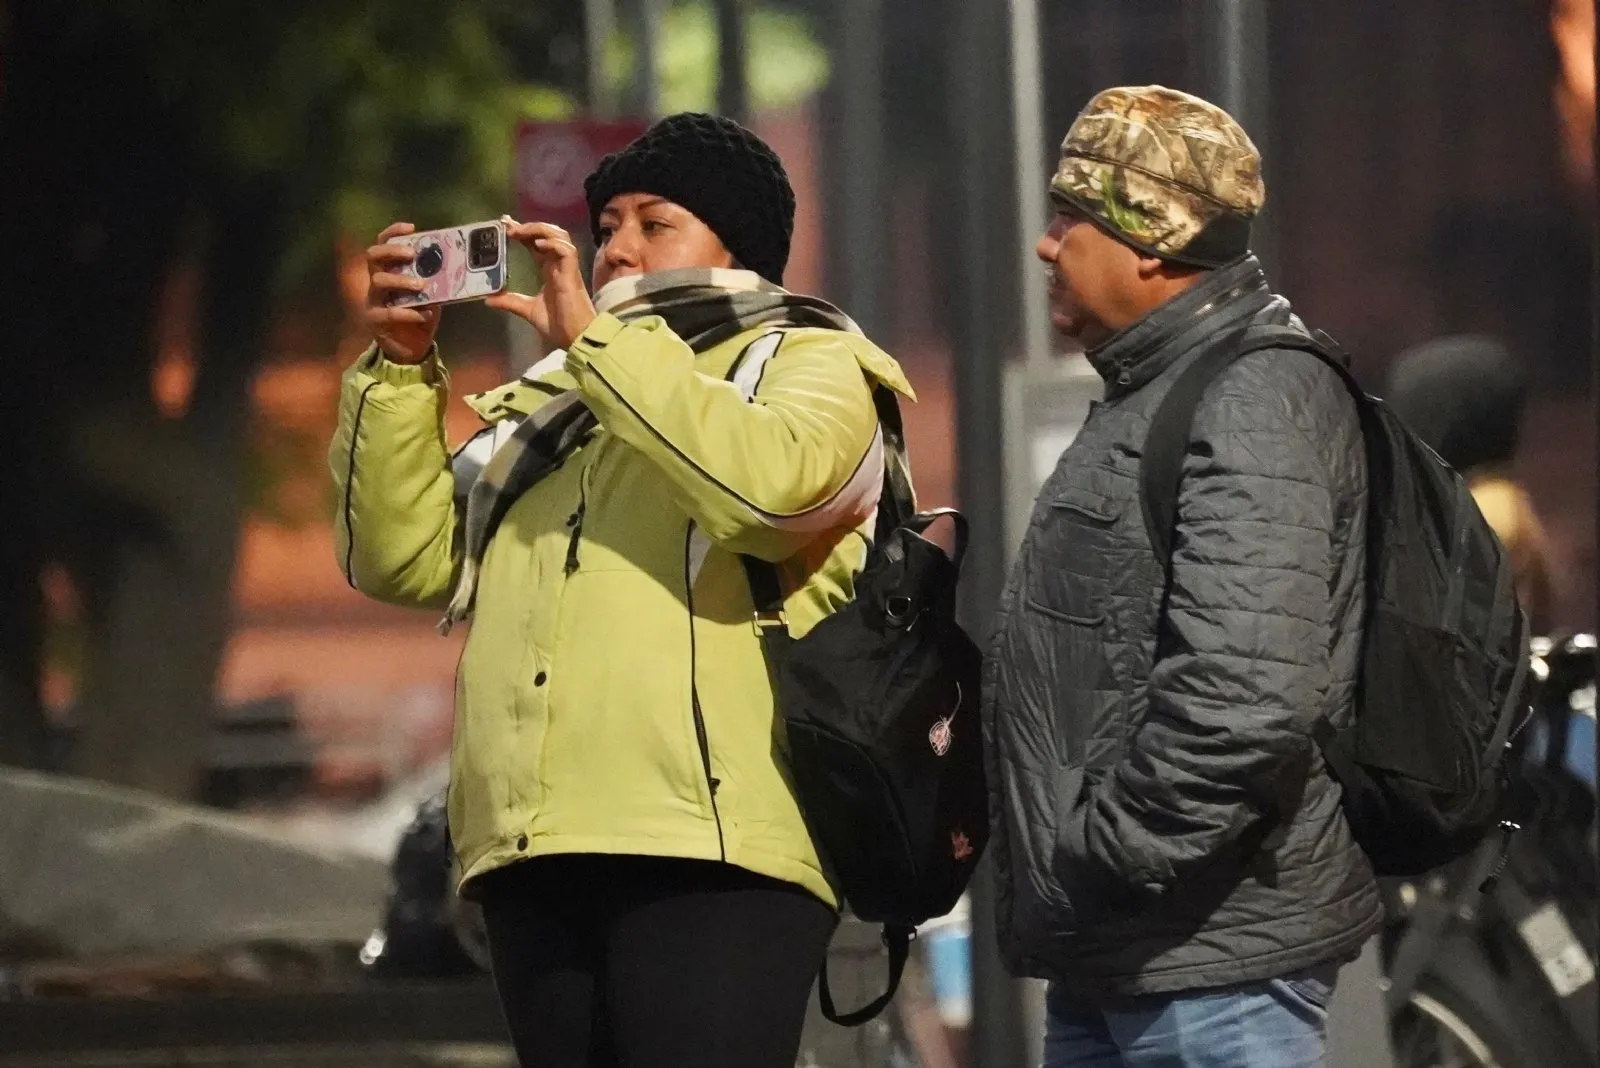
left=1139, top=326, right=1365, bottom=571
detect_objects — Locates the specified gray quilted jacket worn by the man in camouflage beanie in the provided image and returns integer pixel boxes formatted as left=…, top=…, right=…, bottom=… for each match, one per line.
left=984, top=259, right=1382, bottom=999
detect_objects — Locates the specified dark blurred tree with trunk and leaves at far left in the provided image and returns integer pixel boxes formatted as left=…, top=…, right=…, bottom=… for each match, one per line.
left=0, top=0, right=582, bottom=798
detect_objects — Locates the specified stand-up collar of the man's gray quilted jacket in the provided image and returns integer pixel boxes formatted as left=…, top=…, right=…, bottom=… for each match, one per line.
left=1085, top=256, right=1274, bottom=398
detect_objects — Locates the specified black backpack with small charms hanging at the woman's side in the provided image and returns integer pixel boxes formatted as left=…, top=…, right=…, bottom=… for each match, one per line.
left=730, top=340, right=989, bottom=1026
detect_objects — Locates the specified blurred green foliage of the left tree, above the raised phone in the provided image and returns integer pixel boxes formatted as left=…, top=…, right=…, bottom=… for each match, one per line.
left=91, top=0, right=581, bottom=289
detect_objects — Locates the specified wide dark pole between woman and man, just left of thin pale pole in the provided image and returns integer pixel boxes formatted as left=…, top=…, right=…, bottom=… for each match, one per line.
left=946, top=0, right=1027, bottom=1068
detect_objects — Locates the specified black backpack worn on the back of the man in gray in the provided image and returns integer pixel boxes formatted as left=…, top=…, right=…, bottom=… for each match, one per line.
left=1139, top=326, right=1528, bottom=875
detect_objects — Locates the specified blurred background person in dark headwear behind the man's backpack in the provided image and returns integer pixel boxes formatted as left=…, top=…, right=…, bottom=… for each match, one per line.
left=1384, top=334, right=1554, bottom=635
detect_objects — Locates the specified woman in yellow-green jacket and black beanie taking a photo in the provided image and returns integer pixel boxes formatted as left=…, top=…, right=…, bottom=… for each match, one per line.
left=331, top=115, right=910, bottom=1068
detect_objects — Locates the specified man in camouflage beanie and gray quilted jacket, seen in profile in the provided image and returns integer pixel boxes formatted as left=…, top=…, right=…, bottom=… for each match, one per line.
left=986, top=86, right=1381, bottom=1068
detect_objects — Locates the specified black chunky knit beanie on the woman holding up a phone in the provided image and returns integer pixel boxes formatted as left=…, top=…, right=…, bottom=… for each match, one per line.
left=584, top=112, right=795, bottom=285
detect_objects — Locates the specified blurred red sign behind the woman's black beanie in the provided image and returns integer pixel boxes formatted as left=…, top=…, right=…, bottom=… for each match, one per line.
left=514, top=120, right=645, bottom=232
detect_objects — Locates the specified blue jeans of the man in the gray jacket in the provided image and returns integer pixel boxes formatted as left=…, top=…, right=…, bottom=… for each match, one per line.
left=1045, top=964, right=1339, bottom=1068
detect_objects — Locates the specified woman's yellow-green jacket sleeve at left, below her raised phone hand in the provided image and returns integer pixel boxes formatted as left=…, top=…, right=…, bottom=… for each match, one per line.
left=328, top=345, right=459, bottom=608
